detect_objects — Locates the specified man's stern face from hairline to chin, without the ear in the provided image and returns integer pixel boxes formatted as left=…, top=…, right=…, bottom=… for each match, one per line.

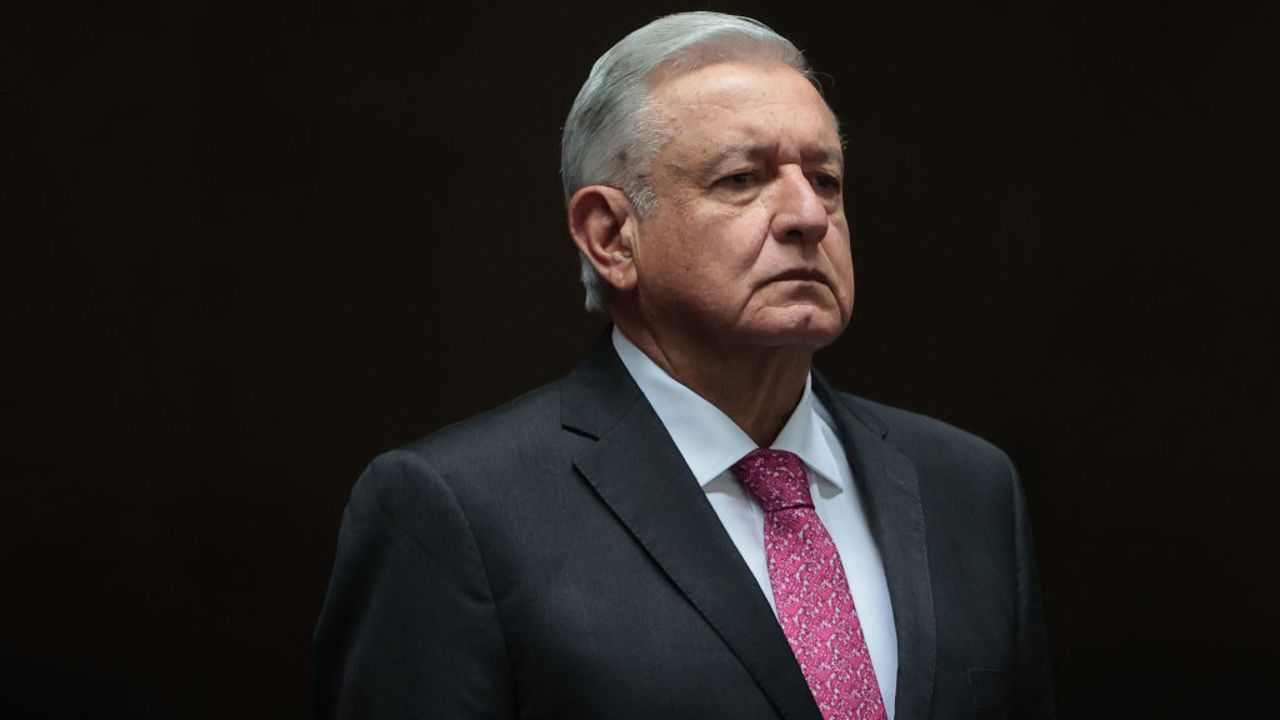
left=634, top=63, right=854, bottom=350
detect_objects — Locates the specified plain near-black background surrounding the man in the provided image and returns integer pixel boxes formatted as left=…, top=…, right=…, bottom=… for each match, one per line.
left=0, top=0, right=1280, bottom=720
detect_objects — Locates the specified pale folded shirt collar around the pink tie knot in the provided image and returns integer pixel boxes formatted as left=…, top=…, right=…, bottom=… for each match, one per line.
left=613, top=325, right=844, bottom=491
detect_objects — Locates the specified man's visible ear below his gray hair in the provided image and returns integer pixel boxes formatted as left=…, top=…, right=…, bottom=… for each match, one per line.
left=568, top=184, right=639, bottom=292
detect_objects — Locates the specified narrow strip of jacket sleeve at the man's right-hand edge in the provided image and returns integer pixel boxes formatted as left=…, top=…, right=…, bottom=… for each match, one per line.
left=1010, top=465, right=1055, bottom=720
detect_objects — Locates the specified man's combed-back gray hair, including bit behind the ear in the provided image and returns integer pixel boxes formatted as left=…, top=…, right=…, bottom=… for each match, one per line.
left=561, top=12, right=820, bottom=313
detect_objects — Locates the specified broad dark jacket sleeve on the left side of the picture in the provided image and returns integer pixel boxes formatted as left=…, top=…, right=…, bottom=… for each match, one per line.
left=314, top=451, right=513, bottom=720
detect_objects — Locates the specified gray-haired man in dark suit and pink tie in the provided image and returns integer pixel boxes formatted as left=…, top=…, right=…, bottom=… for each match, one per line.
left=316, top=13, right=1052, bottom=720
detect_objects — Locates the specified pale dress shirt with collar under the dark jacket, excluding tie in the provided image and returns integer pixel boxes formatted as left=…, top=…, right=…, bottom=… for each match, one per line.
left=613, top=327, right=897, bottom=720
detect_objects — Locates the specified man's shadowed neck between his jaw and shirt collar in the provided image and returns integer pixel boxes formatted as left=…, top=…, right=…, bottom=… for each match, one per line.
left=614, top=314, right=813, bottom=447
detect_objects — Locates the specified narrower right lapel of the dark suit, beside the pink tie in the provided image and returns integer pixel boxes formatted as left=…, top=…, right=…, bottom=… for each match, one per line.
left=814, top=372, right=937, bottom=717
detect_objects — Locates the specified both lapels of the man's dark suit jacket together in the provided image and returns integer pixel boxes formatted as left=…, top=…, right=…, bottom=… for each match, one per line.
left=561, top=336, right=937, bottom=720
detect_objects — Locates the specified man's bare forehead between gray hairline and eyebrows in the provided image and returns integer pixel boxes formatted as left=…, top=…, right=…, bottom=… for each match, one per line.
left=650, top=63, right=840, bottom=159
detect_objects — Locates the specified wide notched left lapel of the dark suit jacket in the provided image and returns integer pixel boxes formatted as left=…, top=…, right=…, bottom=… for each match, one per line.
left=561, top=342, right=820, bottom=720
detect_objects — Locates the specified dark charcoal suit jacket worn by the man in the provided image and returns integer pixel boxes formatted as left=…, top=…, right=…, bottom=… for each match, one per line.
left=315, top=342, right=1052, bottom=720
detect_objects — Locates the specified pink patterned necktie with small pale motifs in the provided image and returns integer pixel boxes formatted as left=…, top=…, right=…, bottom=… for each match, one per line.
left=733, top=447, right=887, bottom=720
